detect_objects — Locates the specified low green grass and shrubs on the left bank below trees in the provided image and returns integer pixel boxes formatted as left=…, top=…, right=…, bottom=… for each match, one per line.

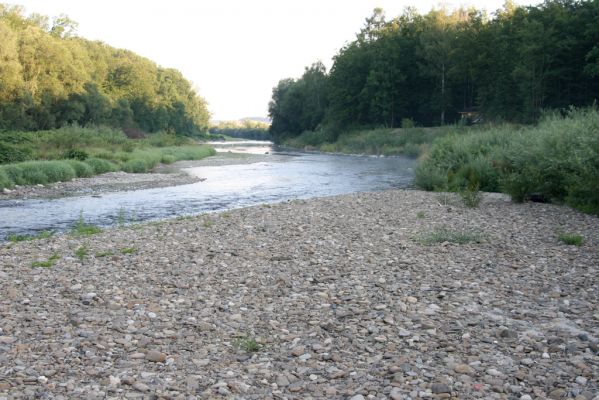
left=0, top=126, right=216, bottom=190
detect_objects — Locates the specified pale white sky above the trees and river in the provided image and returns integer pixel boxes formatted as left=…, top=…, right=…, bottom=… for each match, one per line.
left=12, top=0, right=539, bottom=120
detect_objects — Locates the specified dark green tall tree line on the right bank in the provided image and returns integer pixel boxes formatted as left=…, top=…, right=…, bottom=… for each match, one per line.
left=269, top=0, right=599, bottom=140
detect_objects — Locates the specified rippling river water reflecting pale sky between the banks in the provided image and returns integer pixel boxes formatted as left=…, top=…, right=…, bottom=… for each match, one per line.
left=0, top=142, right=415, bottom=240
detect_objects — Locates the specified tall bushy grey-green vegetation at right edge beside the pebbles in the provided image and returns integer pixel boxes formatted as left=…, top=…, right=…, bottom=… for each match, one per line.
left=415, top=108, right=599, bottom=214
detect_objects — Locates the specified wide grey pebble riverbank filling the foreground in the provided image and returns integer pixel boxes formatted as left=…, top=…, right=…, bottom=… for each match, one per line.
left=0, top=191, right=599, bottom=400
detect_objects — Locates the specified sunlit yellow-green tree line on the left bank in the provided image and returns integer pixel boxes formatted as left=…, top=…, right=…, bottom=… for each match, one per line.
left=0, top=4, right=209, bottom=135
